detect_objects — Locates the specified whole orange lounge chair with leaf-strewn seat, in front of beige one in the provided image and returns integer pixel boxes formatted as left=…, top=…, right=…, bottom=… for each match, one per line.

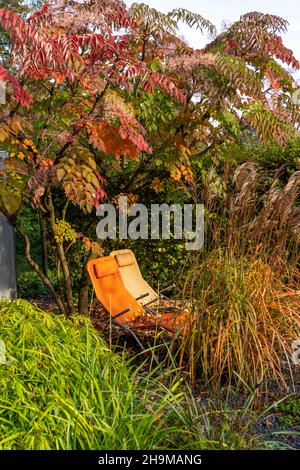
left=87, top=256, right=190, bottom=349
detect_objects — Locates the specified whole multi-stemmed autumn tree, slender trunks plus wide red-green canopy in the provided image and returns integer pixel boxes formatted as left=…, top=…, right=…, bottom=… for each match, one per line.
left=0, top=0, right=299, bottom=313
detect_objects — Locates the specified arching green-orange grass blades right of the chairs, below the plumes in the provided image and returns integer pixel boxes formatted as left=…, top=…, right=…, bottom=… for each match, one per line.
left=176, top=251, right=300, bottom=387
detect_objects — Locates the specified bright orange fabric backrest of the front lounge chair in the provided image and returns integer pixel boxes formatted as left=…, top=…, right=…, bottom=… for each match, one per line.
left=87, top=256, right=145, bottom=324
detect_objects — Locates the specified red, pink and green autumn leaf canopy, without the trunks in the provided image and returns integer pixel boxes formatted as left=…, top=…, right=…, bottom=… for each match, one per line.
left=0, top=0, right=299, bottom=211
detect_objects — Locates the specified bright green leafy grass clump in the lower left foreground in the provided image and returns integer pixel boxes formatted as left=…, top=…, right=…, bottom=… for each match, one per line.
left=0, top=300, right=185, bottom=450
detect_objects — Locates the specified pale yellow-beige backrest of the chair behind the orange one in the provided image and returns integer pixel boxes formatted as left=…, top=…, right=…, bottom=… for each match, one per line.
left=110, top=250, right=158, bottom=305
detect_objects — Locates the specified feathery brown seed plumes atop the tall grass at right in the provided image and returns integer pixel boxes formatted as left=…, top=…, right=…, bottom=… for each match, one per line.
left=202, top=162, right=300, bottom=272
